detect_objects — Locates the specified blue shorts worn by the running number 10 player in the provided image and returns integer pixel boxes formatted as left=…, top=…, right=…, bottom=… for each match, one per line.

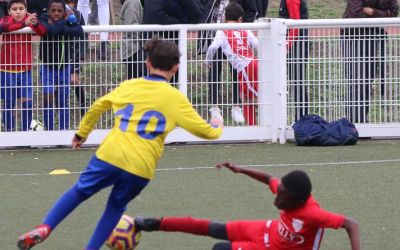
left=76, top=155, right=149, bottom=204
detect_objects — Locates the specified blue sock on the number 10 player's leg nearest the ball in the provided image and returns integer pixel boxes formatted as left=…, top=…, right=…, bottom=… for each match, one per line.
left=86, top=198, right=126, bottom=249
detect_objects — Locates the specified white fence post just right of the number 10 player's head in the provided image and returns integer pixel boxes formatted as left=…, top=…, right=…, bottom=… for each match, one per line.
left=178, top=27, right=188, bottom=96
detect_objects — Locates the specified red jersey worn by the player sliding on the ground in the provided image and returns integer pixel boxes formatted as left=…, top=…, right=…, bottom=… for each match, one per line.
left=265, top=178, right=345, bottom=250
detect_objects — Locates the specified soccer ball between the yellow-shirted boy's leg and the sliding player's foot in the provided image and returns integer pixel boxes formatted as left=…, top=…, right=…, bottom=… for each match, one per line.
left=106, top=214, right=141, bottom=250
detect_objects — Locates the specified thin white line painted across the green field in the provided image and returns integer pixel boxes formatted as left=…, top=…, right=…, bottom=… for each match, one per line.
left=0, top=159, right=400, bottom=176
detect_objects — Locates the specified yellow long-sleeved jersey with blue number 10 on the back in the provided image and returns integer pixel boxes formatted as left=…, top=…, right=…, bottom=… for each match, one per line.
left=77, top=76, right=222, bottom=179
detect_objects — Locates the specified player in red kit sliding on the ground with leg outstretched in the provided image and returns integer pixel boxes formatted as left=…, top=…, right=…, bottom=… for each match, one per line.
left=135, top=162, right=360, bottom=250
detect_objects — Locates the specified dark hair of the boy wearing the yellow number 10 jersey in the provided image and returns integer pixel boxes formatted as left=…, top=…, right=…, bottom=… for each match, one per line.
left=143, top=36, right=181, bottom=71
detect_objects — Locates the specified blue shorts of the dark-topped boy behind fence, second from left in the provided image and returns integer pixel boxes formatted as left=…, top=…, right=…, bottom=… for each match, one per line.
left=40, top=65, right=71, bottom=94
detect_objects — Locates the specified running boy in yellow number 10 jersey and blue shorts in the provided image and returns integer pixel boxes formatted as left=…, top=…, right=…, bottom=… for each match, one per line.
left=18, top=38, right=223, bottom=250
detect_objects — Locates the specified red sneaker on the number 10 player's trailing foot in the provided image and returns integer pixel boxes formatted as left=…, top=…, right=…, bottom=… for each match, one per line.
left=17, top=224, right=51, bottom=250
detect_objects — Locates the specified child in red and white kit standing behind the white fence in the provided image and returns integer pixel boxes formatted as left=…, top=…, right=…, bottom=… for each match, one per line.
left=205, top=3, right=258, bottom=125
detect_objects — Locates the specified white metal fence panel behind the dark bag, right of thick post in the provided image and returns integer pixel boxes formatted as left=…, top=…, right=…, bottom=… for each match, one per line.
left=287, top=18, right=400, bottom=141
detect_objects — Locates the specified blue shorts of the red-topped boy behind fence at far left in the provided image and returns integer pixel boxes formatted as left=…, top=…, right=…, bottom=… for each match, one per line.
left=0, top=70, right=33, bottom=100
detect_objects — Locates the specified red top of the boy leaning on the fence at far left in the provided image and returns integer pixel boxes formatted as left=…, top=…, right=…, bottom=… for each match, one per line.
left=0, top=16, right=46, bottom=72
